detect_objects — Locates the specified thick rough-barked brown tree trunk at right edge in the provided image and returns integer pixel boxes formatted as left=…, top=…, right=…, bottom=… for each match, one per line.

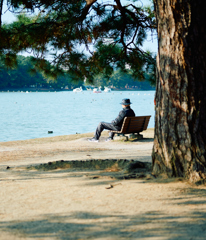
left=152, top=0, right=206, bottom=182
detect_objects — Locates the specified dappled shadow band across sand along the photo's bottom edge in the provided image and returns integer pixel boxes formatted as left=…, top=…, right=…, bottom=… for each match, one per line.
left=0, top=208, right=206, bottom=240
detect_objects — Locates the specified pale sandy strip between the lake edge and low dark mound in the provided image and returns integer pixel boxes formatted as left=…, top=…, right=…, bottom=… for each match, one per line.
left=0, top=129, right=154, bottom=166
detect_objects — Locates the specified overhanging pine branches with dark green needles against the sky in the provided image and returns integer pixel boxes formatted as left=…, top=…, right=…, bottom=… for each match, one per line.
left=0, top=0, right=156, bottom=82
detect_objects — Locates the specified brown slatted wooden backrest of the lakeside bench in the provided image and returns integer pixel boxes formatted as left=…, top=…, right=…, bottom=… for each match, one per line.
left=121, top=116, right=151, bottom=133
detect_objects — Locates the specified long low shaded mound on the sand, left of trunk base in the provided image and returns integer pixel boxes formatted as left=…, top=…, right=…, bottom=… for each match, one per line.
left=1, top=159, right=155, bottom=184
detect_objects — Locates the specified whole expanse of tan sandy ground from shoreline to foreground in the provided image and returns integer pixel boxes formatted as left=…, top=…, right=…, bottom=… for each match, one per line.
left=0, top=129, right=206, bottom=240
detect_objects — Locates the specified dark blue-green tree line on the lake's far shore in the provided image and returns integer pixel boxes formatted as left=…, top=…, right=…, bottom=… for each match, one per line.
left=0, top=55, right=154, bottom=90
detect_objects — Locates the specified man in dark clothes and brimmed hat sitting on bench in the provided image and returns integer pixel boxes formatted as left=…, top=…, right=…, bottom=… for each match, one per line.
left=88, top=98, right=135, bottom=142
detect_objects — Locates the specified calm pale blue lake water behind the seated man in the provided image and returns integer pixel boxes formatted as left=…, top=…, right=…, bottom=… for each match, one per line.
left=0, top=91, right=155, bottom=142
